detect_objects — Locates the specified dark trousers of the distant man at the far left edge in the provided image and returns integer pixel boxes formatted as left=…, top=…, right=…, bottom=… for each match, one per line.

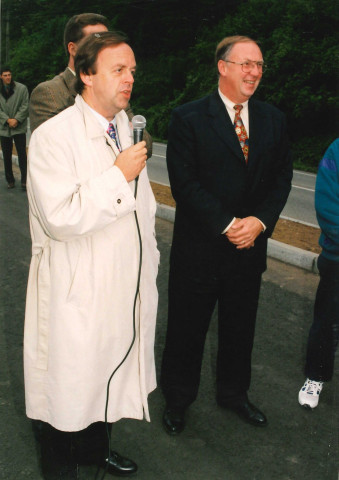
left=1, top=133, right=27, bottom=185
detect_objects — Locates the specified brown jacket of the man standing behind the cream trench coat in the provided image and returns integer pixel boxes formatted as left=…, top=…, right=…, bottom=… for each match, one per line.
left=29, top=68, right=152, bottom=158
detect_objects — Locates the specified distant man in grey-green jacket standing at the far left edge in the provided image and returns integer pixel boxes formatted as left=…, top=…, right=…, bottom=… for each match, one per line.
left=0, top=67, right=28, bottom=190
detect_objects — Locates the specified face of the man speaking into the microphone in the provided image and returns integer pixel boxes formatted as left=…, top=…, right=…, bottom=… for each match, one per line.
left=81, top=43, right=136, bottom=121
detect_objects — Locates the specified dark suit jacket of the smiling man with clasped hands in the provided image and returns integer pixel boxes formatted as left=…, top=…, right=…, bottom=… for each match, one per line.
left=167, top=91, right=292, bottom=282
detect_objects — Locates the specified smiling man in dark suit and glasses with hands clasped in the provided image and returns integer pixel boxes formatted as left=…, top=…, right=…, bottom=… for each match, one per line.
left=161, top=36, right=292, bottom=435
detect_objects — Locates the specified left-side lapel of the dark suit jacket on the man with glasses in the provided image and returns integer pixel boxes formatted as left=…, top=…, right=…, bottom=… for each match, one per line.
left=207, top=91, right=245, bottom=162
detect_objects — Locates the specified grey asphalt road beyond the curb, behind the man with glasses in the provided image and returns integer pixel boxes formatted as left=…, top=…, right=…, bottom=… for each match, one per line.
left=147, top=143, right=318, bottom=227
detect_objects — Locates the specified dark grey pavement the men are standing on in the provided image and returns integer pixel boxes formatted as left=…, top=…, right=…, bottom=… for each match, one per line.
left=0, top=167, right=339, bottom=480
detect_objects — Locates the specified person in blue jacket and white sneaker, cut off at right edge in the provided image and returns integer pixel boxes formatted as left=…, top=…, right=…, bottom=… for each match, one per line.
left=298, top=138, right=339, bottom=408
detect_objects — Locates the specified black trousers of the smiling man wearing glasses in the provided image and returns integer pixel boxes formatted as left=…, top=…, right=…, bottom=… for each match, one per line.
left=160, top=260, right=261, bottom=408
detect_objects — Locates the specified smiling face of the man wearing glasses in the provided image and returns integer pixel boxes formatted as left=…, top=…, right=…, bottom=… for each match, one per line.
left=218, top=42, right=263, bottom=103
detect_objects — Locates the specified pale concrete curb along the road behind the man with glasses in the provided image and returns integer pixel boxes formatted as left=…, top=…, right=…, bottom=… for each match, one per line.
left=156, top=203, right=318, bottom=273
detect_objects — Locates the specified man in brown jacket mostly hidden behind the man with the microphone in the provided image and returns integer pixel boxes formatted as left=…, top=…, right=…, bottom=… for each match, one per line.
left=29, top=13, right=152, bottom=157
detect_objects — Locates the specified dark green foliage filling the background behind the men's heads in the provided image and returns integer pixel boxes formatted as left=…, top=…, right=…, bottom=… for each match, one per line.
left=1, top=0, right=339, bottom=170
